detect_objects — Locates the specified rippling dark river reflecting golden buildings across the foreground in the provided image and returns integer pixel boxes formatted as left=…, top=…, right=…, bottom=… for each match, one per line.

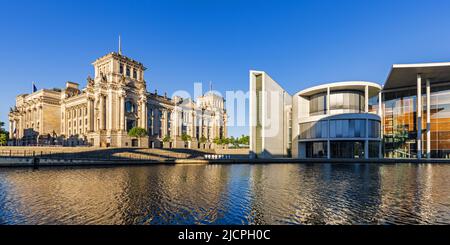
left=0, top=164, right=450, bottom=224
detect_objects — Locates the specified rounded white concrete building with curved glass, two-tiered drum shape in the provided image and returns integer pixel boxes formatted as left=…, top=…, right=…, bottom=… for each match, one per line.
left=292, top=81, right=381, bottom=158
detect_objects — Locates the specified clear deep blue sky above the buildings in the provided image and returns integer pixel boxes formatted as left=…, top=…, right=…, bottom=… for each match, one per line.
left=0, top=0, right=450, bottom=135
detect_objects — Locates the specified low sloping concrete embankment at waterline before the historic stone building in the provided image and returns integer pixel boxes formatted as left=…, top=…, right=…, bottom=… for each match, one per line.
left=0, top=147, right=248, bottom=167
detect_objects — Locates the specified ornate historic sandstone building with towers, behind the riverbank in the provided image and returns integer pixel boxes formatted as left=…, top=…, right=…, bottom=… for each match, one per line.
left=9, top=52, right=226, bottom=148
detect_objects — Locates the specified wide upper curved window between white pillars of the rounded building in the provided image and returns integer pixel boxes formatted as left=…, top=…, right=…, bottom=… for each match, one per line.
left=330, top=91, right=364, bottom=114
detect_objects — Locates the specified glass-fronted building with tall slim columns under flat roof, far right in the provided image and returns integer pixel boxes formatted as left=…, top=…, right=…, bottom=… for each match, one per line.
left=382, top=62, right=450, bottom=158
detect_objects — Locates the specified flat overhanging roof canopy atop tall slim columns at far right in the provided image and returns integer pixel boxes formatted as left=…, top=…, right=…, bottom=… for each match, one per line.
left=384, top=62, right=450, bottom=89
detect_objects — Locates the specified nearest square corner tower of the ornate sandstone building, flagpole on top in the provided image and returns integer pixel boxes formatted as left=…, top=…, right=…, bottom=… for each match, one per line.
left=86, top=48, right=148, bottom=147
